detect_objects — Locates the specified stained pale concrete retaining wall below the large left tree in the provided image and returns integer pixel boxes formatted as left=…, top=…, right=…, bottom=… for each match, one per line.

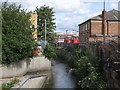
left=0, top=56, right=51, bottom=78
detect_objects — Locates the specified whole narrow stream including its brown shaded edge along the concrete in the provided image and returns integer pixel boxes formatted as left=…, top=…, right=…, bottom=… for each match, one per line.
left=26, top=60, right=76, bottom=90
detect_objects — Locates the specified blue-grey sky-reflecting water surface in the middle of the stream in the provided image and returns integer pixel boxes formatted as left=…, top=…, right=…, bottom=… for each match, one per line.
left=52, top=61, right=75, bottom=88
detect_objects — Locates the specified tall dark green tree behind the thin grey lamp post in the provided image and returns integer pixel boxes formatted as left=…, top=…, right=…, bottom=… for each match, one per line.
left=35, top=5, right=56, bottom=43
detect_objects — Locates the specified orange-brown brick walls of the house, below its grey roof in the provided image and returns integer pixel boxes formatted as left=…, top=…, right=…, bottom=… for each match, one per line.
left=79, top=20, right=120, bottom=43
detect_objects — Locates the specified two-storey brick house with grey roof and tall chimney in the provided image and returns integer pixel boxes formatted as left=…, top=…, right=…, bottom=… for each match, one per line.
left=79, top=9, right=120, bottom=43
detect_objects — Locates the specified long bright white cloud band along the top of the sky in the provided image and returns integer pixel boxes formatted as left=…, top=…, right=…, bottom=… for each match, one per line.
left=3, top=0, right=88, bottom=13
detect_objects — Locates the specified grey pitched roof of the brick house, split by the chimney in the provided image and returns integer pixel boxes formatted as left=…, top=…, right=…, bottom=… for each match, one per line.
left=91, top=9, right=120, bottom=20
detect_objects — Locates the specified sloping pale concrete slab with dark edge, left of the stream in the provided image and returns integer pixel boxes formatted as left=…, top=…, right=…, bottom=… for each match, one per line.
left=11, top=74, right=48, bottom=90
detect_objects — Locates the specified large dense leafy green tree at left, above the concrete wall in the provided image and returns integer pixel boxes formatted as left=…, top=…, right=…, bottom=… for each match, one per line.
left=2, top=2, right=35, bottom=64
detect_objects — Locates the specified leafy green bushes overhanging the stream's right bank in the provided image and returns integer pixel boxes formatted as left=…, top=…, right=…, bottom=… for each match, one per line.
left=60, top=47, right=108, bottom=88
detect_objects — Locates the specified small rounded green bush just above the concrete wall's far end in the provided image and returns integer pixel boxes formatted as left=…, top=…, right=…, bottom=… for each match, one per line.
left=43, top=44, right=57, bottom=59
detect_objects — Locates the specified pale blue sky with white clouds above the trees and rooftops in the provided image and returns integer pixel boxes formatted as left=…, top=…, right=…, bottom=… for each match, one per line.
left=0, top=0, right=120, bottom=32
